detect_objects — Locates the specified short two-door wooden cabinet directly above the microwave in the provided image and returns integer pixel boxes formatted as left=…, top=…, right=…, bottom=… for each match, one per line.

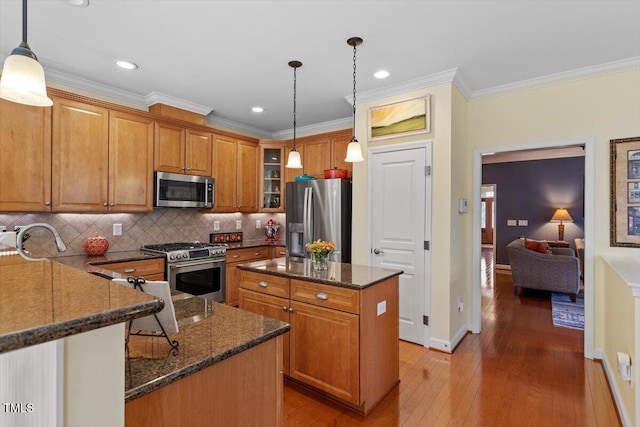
left=153, top=122, right=213, bottom=176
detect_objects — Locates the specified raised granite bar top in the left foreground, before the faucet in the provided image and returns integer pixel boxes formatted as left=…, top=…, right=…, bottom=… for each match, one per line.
left=0, top=255, right=164, bottom=353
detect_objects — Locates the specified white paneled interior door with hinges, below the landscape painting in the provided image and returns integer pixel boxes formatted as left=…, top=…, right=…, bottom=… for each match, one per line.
left=369, top=143, right=431, bottom=345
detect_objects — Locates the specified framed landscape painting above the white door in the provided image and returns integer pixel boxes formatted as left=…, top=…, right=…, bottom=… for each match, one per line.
left=368, top=95, right=431, bottom=141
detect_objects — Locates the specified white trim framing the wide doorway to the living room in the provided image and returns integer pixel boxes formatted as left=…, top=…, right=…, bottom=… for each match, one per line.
left=470, top=137, right=596, bottom=359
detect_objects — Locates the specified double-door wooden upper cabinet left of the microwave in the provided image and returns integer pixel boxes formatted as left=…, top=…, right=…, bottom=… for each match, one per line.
left=52, top=98, right=153, bottom=212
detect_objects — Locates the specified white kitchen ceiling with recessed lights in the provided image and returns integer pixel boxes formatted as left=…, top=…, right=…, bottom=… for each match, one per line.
left=0, top=0, right=640, bottom=136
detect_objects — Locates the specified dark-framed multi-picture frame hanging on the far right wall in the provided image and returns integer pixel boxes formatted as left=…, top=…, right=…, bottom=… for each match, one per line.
left=609, top=136, right=640, bottom=248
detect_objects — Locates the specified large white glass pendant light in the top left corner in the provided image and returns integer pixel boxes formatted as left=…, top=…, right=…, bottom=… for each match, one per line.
left=0, top=0, right=53, bottom=107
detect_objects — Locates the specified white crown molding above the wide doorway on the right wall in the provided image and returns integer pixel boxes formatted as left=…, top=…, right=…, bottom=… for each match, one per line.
left=467, top=56, right=640, bottom=101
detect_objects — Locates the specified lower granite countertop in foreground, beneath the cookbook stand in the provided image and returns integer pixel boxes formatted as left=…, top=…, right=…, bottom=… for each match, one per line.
left=125, top=294, right=290, bottom=401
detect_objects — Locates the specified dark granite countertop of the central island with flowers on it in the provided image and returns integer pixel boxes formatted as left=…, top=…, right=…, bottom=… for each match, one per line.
left=238, top=257, right=403, bottom=289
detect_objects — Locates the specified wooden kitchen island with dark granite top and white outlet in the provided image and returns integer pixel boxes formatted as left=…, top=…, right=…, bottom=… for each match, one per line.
left=238, top=258, right=402, bottom=415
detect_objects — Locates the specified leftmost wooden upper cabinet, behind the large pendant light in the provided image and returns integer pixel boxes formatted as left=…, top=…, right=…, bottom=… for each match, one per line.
left=0, top=99, right=51, bottom=212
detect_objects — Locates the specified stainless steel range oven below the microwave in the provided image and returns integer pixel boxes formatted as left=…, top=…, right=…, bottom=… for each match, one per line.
left=142, top=242, right=226, bottom=302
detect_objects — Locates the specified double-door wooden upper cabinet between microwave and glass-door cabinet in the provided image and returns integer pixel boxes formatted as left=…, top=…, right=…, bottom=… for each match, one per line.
left=213, top=135, right=258, bottom=212
